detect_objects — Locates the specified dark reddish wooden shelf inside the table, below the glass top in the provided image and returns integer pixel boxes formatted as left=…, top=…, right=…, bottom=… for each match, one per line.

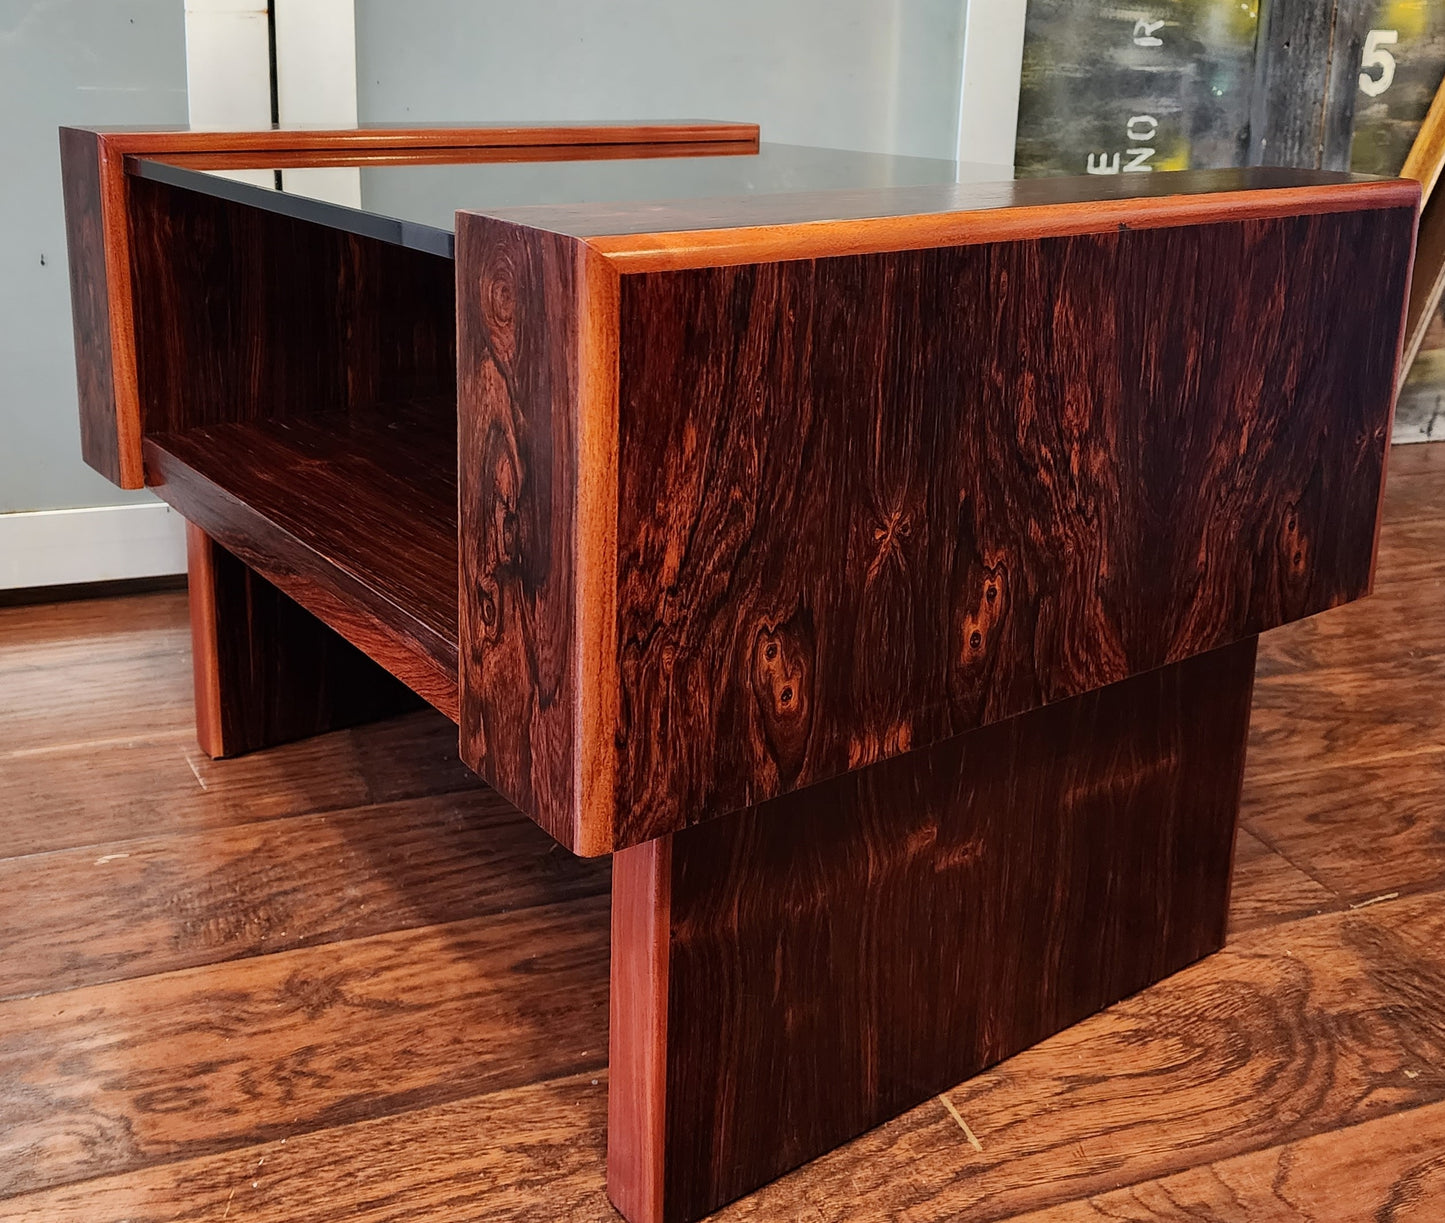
left=146, top=400, right=457, bottom=721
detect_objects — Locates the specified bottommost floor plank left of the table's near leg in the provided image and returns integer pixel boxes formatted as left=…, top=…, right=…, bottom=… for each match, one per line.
left=0, top=1071, right=618, bottom=1223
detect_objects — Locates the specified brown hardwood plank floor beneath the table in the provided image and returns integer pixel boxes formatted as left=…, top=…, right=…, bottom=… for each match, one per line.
left=0, top=444, right=1445, bottom=1223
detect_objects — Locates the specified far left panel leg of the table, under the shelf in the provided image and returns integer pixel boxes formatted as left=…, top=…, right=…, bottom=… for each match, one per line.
left=186, top=526, right=423, bottom=756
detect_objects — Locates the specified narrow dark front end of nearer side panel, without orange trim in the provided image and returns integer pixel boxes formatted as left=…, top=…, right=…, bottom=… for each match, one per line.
left=457, top=214, right=611, bottom=853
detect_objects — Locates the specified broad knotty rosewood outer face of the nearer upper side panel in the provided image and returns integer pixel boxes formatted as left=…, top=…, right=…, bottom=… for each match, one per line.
left=616, top=207, right=1413, bottom=844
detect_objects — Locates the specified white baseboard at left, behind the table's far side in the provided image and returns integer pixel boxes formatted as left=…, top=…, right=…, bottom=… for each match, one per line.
left=0, top=502, right=185, bottom=590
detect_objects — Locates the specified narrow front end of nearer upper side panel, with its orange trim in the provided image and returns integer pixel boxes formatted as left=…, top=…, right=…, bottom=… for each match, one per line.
left=457, top=214, right=617, bottom=854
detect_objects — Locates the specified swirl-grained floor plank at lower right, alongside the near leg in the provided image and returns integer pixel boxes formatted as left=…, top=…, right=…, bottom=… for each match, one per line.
left=705, top=893, right=1445, bottom=1223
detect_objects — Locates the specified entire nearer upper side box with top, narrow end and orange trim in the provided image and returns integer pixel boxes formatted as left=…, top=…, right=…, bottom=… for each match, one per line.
left=457, top=172, right=1418, bottom=853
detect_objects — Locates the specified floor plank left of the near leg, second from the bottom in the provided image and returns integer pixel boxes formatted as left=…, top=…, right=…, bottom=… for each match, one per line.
left=0, top=898, right=608, bottom=1198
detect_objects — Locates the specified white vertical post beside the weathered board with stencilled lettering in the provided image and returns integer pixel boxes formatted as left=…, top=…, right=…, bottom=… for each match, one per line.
left=958, top=0, right=1029, bottom=178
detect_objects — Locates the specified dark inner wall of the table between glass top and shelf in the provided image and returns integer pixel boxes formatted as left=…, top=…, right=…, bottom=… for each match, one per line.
left=129, top=178, right=457, bottom=434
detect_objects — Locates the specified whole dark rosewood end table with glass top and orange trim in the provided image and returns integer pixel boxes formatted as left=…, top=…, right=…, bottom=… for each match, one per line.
left=61, top=123, right=1419, bottom=1223
